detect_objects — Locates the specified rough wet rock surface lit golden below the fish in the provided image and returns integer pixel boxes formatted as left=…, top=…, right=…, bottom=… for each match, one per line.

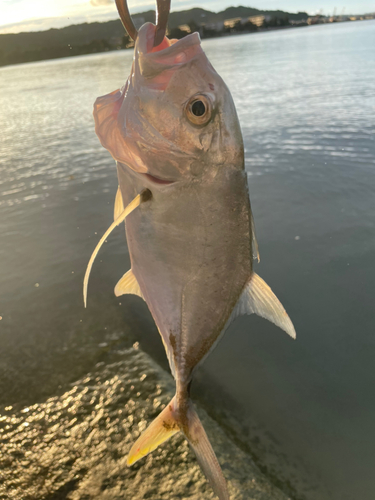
left=0, top=344, right=287, bottom=500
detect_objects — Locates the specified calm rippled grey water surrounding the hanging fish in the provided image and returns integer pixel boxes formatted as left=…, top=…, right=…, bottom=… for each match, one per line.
left=0, top=21, right=375, bottom=500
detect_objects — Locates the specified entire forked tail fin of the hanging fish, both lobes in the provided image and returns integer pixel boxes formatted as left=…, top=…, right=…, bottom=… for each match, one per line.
left=127, top=396, right=229, bottom=500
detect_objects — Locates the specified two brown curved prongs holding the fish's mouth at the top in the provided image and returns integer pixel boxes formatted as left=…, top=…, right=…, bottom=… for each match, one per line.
left=115, top=0, right=171, bottom=47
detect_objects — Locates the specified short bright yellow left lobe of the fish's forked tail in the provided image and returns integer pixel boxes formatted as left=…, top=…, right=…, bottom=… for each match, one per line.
left=127, top=398, right=180, bottom=466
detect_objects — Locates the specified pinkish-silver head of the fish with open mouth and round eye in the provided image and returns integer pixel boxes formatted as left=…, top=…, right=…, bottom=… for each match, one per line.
left=94, top=23, right=243, bottom=185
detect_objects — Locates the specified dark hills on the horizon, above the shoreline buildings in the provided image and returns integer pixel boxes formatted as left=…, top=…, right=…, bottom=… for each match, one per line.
left=0, top=6, right=308, bottom=65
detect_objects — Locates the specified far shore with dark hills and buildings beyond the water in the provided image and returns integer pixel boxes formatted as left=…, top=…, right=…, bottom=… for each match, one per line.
left=0, top=6, right=308, bottom=66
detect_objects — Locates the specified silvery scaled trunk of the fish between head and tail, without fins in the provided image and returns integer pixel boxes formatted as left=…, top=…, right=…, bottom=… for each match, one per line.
left=118, top=141, right=252, bottom=383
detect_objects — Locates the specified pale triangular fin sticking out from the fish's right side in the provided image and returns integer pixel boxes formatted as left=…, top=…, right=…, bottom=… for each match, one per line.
left=232, top=273, right=296, bottom=339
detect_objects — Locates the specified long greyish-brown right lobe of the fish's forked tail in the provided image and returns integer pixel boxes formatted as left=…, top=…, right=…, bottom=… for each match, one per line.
left=181, top=401, right=229, bottom=500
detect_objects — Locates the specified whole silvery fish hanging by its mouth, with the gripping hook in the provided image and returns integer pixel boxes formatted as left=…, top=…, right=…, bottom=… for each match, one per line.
left=84, top=0, right=296, bottom=500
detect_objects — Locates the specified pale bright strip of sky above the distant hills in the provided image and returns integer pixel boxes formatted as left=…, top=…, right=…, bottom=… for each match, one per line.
left=0, top=0, right=375, bottom=33
